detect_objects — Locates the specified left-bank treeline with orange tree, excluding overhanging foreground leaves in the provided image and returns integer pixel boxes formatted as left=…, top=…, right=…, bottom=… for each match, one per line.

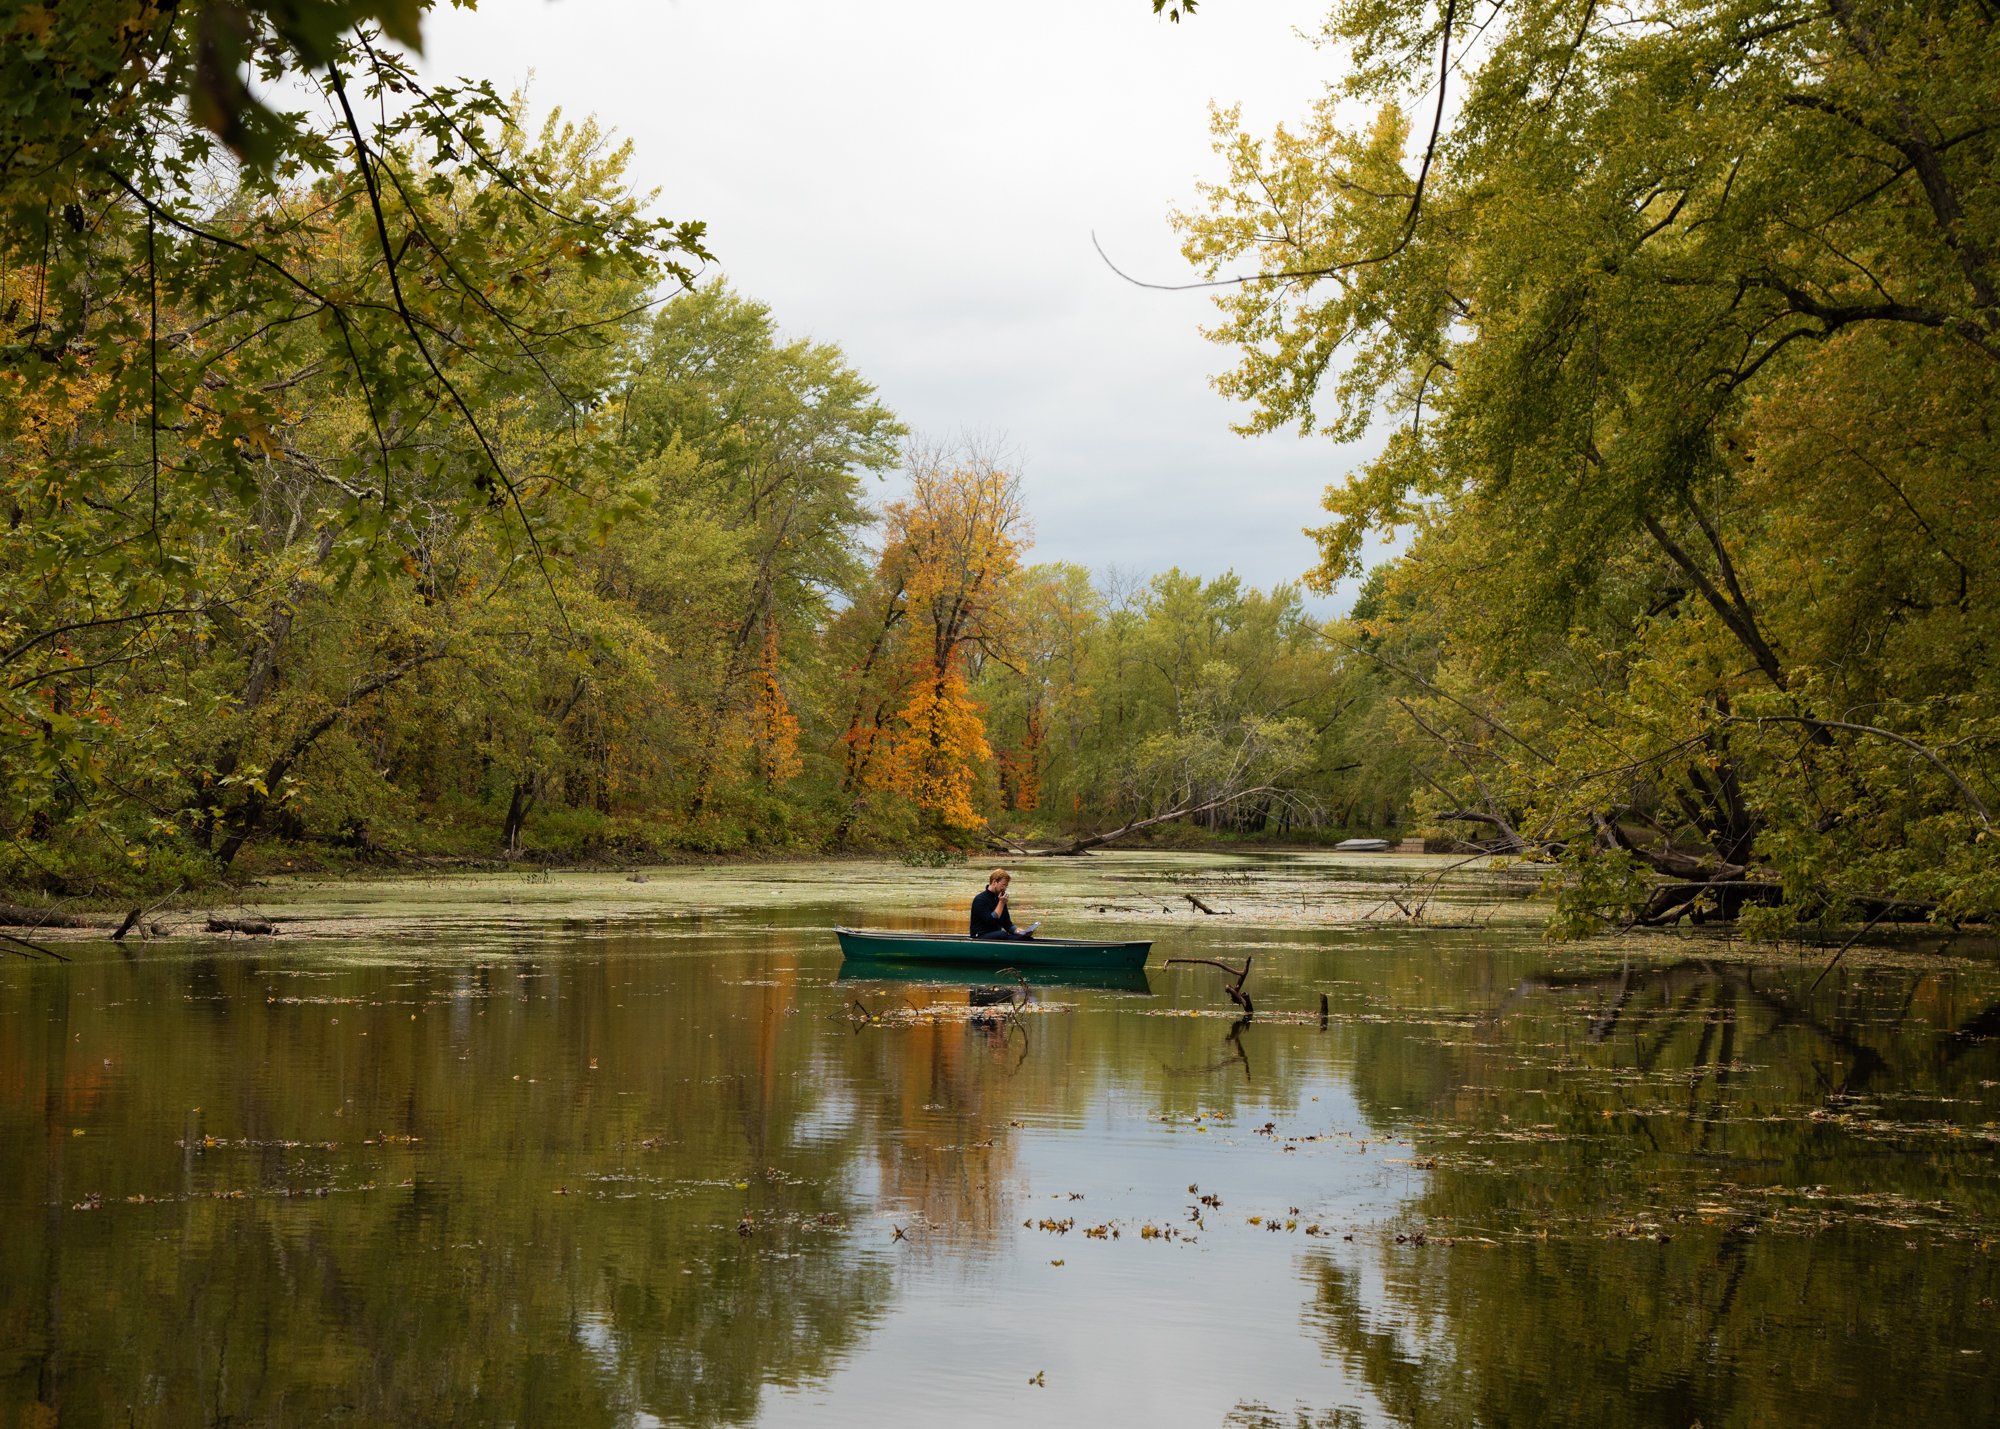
left=6, top=258, right=1354, bottom=891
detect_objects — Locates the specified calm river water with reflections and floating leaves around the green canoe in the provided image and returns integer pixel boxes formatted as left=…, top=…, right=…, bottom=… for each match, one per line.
left=0, top=855, right=2000, bottom=1429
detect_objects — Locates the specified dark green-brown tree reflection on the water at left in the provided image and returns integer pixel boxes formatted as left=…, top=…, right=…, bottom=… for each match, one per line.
left=0, top=940, right=890, bottom=1425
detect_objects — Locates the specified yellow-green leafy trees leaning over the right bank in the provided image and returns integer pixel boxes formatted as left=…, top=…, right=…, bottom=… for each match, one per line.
left=1180, top=0, right=2000, bottom=931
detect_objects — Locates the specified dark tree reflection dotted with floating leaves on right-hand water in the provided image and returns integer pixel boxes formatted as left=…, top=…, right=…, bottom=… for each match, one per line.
left=1306, top=944, right=2000, bottom=1425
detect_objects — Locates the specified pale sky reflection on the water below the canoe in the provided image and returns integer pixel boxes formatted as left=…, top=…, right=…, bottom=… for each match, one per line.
left=760, top=1081, right=1422, bottom=1425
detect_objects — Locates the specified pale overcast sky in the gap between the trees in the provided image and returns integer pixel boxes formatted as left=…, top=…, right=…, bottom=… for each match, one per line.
left=412, top=0, right=1358, bottom=612
